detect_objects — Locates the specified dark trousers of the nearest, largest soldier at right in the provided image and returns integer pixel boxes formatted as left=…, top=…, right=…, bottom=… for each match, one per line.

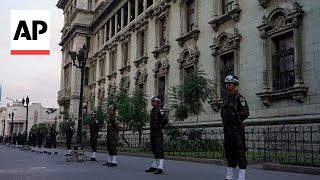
left=223, top=134, right=247, bottom=169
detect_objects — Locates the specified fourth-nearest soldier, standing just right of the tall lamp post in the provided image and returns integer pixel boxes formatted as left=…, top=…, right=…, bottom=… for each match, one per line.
left=90, top=111, right=100, bottom=161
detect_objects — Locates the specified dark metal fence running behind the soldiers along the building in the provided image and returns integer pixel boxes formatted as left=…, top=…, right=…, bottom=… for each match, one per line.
left=59, top=125, right=320, bottom=167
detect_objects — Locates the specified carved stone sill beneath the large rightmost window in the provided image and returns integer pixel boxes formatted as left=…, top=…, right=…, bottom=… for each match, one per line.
left=257, top=87, right=308, bottom=106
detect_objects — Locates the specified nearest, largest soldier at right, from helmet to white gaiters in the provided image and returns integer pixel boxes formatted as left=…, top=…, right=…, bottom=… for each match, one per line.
left=221, top=75, right=249, bottom=180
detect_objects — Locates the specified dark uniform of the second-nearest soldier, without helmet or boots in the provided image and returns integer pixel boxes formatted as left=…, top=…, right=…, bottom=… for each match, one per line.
left=150, top=107, right=168, bottom=159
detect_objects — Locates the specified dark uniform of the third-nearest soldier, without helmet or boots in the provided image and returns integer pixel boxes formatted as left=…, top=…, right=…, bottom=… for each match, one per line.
left=107, top=115, right=119, bottom=156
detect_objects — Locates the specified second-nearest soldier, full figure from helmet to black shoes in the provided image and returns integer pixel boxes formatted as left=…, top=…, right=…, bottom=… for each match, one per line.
left=146, top=96, right=168, bottom=174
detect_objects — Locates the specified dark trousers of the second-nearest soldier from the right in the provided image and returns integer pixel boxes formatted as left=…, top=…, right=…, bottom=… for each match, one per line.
left=150, top=132, right=164, bottom=159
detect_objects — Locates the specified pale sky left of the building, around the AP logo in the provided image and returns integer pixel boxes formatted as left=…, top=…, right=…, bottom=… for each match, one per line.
left=0, top=0, right=63, bottom=108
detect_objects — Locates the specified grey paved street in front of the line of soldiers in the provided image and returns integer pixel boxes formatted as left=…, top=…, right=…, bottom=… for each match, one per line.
left=0, top=145, right=320, bottom=180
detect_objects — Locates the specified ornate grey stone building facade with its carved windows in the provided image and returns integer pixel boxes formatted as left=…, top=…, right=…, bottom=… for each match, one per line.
left=57, top=0, right=320, bottom=125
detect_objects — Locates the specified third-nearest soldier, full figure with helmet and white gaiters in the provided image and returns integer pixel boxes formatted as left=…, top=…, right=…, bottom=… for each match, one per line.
left=103, top=105, right=120, bottom=167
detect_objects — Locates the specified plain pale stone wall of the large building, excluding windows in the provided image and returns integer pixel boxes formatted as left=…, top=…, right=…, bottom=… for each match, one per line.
left=57, top=0, right=320, bottom=124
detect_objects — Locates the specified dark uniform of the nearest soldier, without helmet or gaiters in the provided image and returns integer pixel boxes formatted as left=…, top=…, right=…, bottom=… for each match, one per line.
left=221, top=91, right=249, bottom=169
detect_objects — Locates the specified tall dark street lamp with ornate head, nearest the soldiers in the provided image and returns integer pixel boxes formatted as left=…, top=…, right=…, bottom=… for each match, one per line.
left=69, top=45, right=88, bottom=150
